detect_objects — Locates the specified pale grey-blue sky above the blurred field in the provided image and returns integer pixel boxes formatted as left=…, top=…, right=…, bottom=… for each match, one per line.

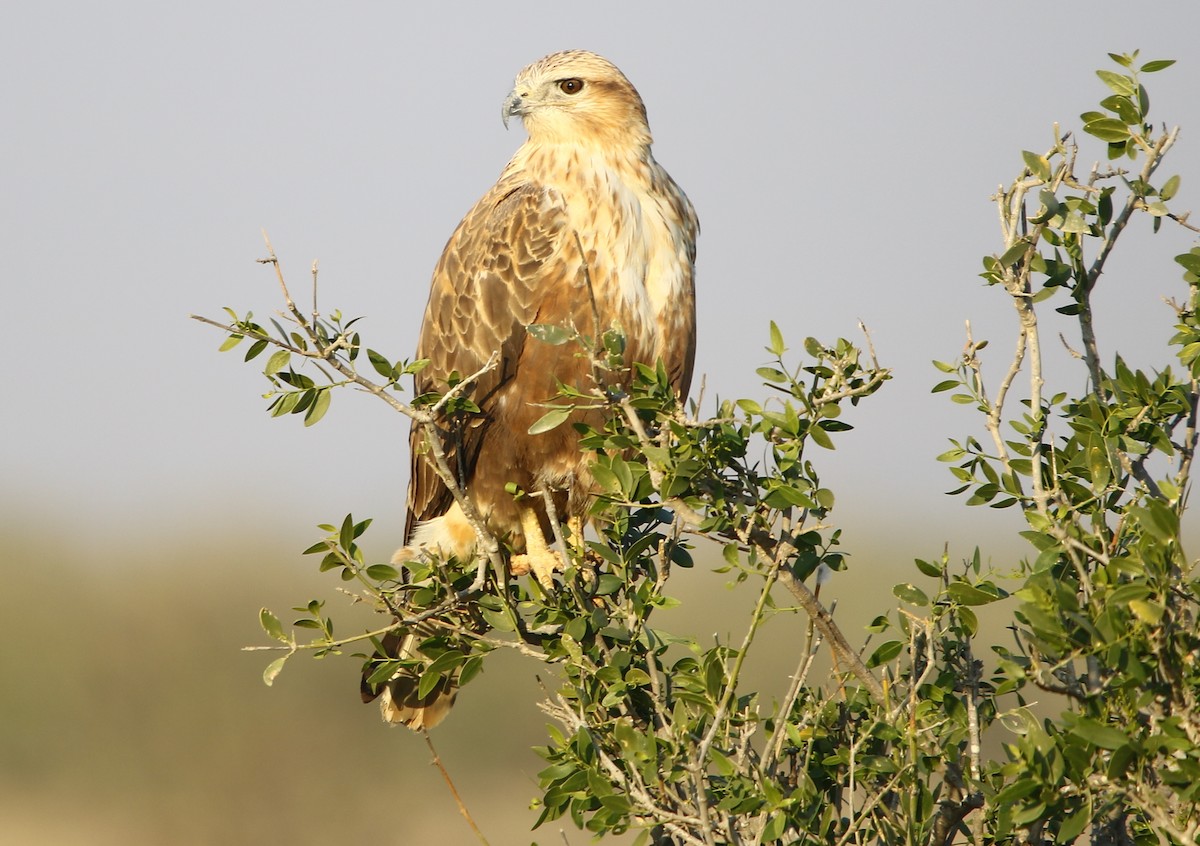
left=0, top=2, right=1200, bottom=556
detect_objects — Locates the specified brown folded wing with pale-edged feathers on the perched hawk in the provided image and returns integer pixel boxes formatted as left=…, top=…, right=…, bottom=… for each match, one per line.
left=404, top=179, right=578, bottom=542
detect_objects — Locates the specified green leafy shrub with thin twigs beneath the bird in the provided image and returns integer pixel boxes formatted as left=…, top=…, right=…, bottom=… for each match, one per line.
left=197, top=53, right=1200, bottom=846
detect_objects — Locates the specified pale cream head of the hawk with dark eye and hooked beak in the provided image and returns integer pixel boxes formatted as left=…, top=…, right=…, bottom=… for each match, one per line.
left=500, top=50, right=650, bottom=146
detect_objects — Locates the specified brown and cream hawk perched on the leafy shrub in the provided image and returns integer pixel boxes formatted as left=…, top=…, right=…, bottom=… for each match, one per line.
left=365, top=50, right=698, bottom=728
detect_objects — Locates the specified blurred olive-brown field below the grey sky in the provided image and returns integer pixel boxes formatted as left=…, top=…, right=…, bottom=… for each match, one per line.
left=0, top=510, right=1003, bottom=846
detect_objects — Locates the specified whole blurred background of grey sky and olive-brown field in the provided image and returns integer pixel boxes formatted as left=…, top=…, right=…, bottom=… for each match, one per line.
left=0, top=0, right=1200, bottom=846
